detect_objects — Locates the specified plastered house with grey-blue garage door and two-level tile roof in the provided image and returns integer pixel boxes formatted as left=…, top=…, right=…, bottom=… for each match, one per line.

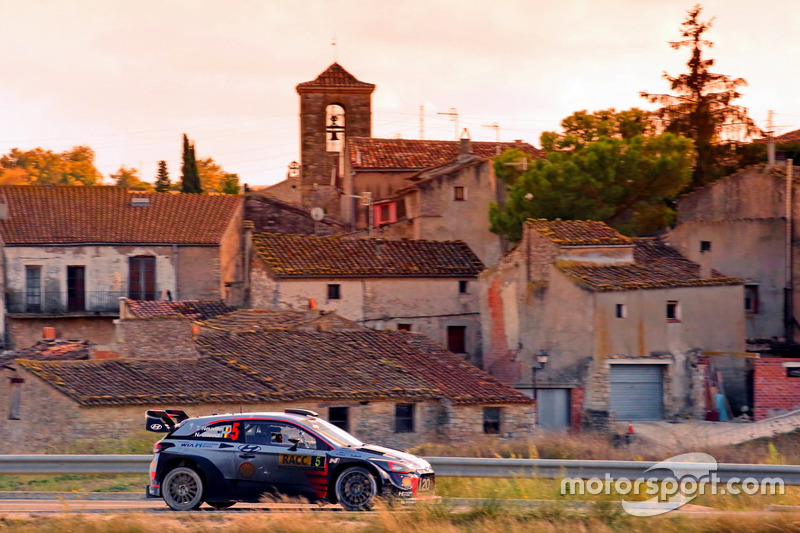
left=480, top=220, right=744, bottom=427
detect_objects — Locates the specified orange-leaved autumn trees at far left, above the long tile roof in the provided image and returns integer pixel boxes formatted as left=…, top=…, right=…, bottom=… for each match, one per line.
left=0, top=146, right=103, bottom=185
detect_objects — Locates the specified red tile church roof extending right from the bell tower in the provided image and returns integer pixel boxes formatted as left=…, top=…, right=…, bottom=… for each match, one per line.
left=347, top=137, right=543, bottom=171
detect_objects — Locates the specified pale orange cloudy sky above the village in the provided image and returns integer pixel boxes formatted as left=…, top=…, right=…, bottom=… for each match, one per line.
left=0, top=0, right=800, bottom=186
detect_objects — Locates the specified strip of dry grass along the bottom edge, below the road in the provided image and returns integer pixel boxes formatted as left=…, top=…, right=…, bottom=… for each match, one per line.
left=0, top=506, right=800, bottom=533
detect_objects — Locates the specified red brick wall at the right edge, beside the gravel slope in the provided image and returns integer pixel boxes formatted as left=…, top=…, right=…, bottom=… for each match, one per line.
left=753, top=357, right=800, bottom=420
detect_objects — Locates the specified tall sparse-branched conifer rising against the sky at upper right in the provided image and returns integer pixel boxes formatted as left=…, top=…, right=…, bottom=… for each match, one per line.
left=640, top=4, right=760, bottom=188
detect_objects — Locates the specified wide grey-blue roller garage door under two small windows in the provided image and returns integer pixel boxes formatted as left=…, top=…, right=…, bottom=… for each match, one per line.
left=610, top=364, right=664, bottom=421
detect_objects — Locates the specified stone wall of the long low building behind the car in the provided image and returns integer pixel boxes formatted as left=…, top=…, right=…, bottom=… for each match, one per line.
left=0, top=370, right=533, bottom=454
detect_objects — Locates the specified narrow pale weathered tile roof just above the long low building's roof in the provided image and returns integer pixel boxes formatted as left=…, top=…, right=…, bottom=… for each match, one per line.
left=203, top=309, right=365, bottom=332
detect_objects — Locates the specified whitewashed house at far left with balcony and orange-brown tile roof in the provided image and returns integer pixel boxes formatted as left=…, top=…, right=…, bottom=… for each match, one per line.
left=0, top=185, right=244, bottom=347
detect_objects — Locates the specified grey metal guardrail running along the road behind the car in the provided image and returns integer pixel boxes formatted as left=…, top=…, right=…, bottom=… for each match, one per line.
left=0, top=455, right=800, bottom=485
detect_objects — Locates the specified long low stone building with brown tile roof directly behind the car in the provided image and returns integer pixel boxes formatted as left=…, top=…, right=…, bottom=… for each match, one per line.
left=0, top=302, right=534, bottom=453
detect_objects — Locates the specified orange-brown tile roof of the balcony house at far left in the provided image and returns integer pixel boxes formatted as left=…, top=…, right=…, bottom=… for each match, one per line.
left=0, top=185, right=242, bottom=245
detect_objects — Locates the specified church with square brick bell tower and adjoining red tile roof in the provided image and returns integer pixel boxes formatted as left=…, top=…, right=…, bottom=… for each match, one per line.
left=261, top=63, right=542, bottom=240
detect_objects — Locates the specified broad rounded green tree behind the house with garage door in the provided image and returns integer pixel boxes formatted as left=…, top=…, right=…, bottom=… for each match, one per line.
left=489, top=133, right=694, bottom=241
